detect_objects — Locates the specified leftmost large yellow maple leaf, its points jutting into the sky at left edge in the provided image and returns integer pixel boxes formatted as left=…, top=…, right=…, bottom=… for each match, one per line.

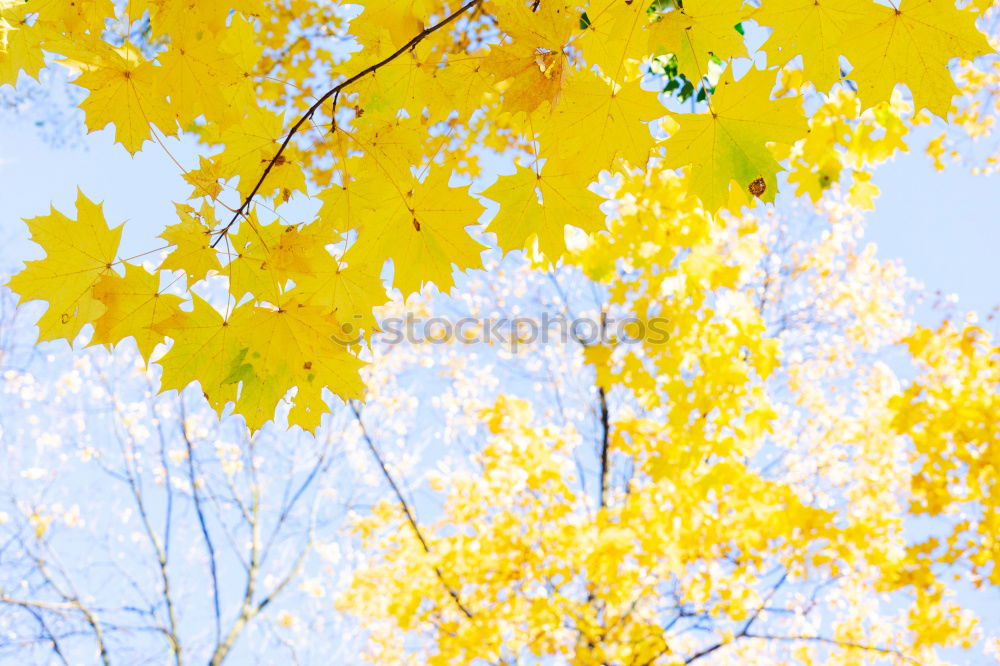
left=8, top=192, right=122, bottom=342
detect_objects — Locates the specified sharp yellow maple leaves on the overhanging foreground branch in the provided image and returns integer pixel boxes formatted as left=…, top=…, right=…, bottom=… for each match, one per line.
left=0, top=0, right=993, bottom=429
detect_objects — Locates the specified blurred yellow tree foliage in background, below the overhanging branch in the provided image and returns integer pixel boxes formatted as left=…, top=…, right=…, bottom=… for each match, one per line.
left=339, top=171, right=1000, bottom=665
